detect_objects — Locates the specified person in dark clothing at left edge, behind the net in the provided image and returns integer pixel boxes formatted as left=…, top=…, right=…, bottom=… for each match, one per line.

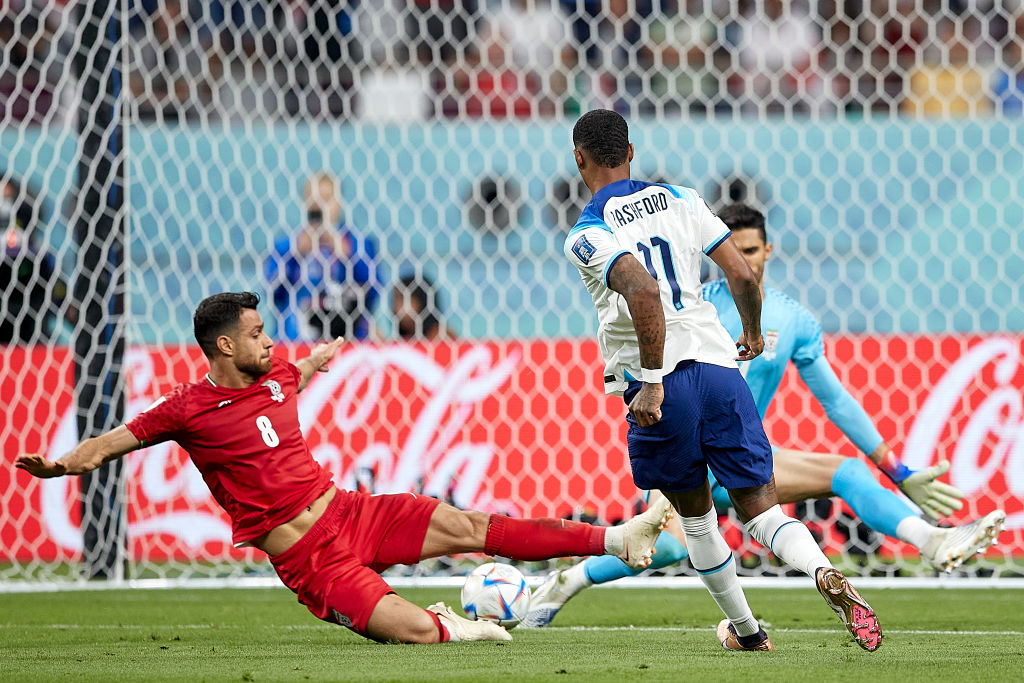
left=0, top=174, right=73, bottom=344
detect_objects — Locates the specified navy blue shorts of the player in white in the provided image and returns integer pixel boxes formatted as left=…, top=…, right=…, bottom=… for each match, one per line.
left=623, top=360, right=772, bottom=492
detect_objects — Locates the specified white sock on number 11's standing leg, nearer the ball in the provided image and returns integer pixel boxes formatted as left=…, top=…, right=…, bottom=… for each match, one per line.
left=680, top=508, right=761, bottom=636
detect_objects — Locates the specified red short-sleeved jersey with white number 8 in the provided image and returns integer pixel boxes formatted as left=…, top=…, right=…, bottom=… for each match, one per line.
left=125, top=358, right=331, bottom=545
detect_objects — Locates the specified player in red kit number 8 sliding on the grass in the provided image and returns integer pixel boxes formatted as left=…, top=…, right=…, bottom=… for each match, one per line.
left=15, top=292, right=672, bottom=643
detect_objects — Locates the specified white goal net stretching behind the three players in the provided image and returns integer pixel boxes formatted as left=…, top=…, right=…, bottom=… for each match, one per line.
left=0, top=0, right=1024, bottom=589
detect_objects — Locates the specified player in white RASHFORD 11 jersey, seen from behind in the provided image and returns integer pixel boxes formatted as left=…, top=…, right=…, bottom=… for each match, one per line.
left=563, top=110, right=882, bottom=650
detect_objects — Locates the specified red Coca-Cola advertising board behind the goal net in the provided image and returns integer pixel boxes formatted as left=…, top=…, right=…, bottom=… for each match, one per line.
left=0, top=336, right=1024, bottom=562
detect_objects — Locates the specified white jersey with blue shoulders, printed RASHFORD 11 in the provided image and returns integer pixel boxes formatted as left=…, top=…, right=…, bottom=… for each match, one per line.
left=564, top=180, right=736, bottom=394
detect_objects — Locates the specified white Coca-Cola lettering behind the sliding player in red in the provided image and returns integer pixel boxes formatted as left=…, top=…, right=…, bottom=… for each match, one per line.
left=41, top=345, right=521, bottom=552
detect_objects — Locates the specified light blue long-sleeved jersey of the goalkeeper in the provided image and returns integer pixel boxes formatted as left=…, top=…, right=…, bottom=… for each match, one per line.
left=703, top=280, right=882, bottom=454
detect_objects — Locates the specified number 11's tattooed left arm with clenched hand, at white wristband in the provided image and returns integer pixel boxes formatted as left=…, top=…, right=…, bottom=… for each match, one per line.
left=607, top=255, right=665, bottom=427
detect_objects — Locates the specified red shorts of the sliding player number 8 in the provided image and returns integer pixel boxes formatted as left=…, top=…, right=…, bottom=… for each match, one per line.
left=270, top=489, right=440, bottom=633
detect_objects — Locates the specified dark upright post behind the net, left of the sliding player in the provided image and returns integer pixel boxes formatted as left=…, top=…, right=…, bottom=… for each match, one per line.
left=72, top=2, right=127, bottom=580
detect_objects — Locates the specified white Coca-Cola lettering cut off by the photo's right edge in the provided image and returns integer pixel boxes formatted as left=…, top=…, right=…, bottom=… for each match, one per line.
left=903, top=337, right=1024, bottom=528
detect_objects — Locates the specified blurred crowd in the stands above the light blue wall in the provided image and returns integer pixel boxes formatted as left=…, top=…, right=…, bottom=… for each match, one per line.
left=0, top=0, right=1024, bottom=122
